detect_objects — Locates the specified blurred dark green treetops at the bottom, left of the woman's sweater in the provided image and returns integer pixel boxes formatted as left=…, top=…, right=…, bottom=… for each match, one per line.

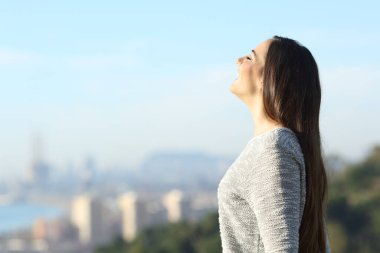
left=95, top=213, right=222, bottom=253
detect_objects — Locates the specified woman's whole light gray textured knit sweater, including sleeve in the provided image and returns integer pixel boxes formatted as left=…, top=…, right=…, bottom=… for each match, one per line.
left=218, top=127, right=330, bottom=253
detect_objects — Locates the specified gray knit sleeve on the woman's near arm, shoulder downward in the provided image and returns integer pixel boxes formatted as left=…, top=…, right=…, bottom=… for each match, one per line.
left=243, top=144, right=302, bottom=253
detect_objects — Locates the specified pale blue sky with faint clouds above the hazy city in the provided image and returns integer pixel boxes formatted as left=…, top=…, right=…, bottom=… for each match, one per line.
left=0, top=1, right=380, bottom=180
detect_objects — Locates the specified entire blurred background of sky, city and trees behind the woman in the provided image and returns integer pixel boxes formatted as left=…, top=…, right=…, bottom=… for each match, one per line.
left=0, top=0, right=380, bottom=253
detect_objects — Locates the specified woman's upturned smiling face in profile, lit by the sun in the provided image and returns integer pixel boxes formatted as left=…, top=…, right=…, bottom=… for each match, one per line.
left=230, top=39, right=272, bottom=101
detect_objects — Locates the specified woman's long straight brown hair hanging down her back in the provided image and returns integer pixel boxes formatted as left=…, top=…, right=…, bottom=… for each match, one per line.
left=262, top=36, right=328, bottom=253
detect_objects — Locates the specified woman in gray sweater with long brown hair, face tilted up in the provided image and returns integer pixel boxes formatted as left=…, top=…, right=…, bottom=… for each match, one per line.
left=218, top=36, right=330, bottom=253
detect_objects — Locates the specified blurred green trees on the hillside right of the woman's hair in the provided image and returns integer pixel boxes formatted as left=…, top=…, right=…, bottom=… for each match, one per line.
left=327, top=146, right=380, bottom=253
